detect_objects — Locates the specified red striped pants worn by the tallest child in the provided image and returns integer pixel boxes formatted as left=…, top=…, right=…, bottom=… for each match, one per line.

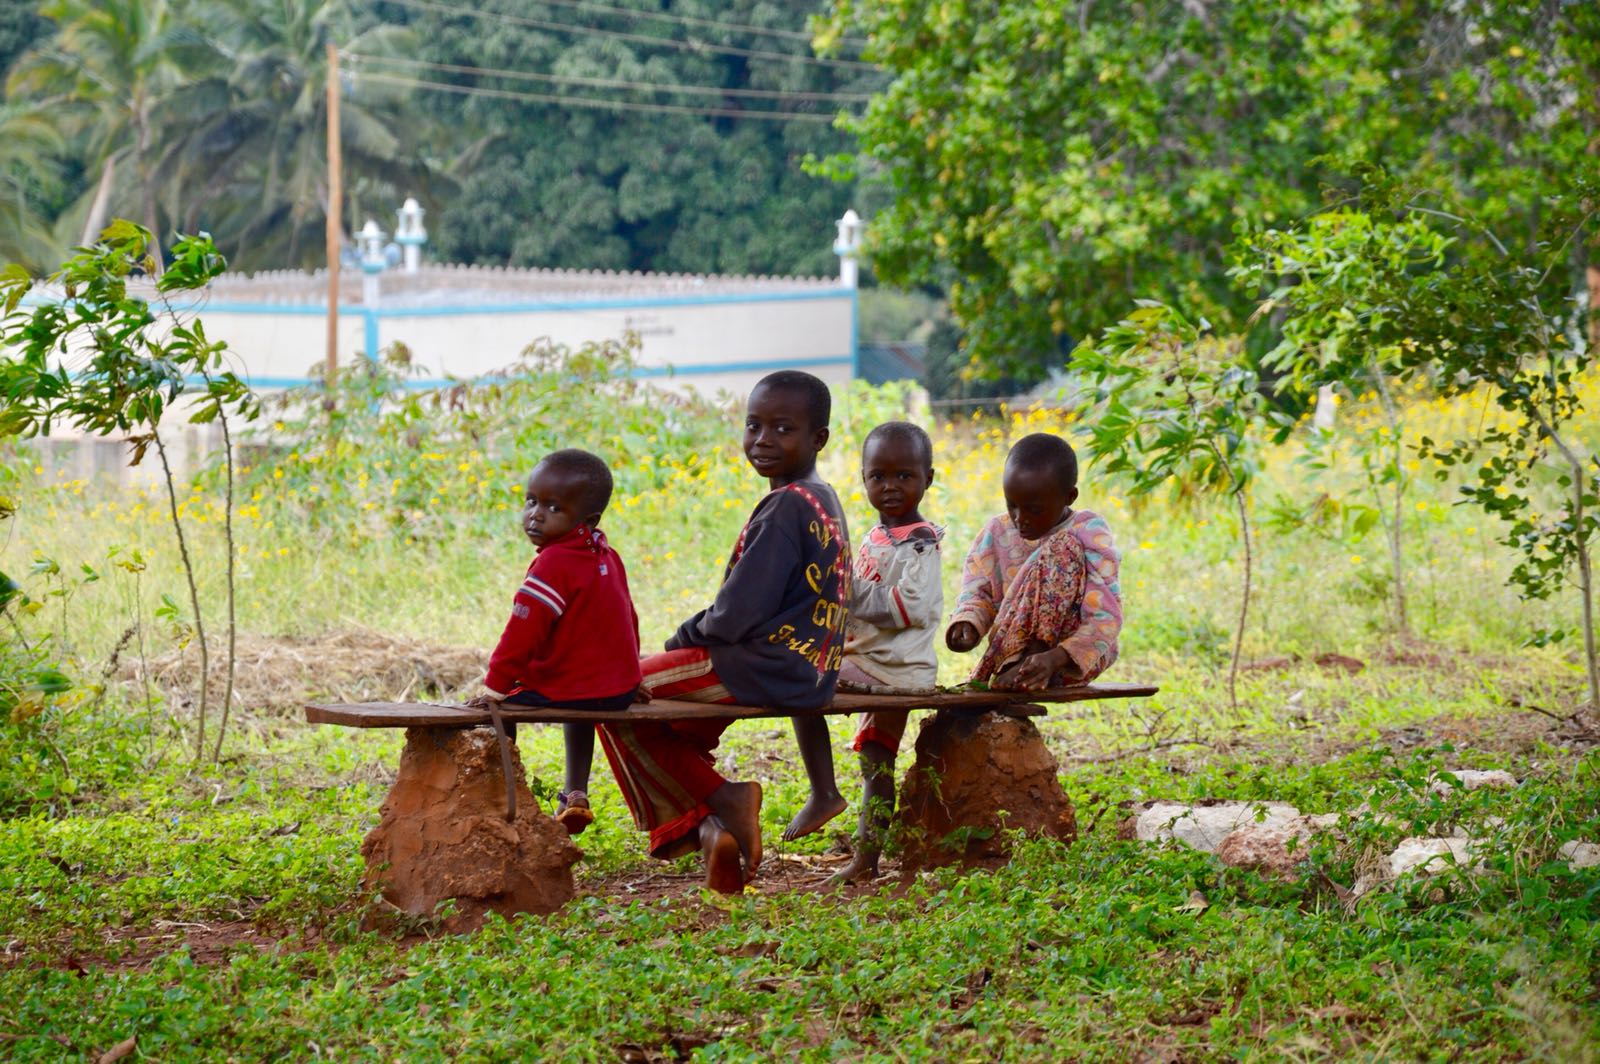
left=597, top=646, right=733, bottom=859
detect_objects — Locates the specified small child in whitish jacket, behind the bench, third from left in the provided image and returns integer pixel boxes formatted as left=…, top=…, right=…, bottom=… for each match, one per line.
left=834, top=421, right=944, bottom=883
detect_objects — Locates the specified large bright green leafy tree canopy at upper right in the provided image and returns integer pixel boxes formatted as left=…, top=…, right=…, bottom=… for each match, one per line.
left=824, top=0, right=1600, bottom=378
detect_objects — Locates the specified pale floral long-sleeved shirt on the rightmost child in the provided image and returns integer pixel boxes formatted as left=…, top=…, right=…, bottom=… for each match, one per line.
left=950, top=510, right=1122, bottom=677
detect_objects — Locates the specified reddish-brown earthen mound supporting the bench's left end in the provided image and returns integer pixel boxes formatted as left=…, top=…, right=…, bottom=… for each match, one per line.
left=362, top=728, right=582, bottom=931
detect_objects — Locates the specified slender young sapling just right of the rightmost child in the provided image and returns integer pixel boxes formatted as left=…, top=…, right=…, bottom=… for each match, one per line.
left=1074, top=301, right=1267, bottom=712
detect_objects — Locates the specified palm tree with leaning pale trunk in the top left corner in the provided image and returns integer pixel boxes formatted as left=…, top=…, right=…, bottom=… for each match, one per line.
left=8, top=0, right=208, bottom=257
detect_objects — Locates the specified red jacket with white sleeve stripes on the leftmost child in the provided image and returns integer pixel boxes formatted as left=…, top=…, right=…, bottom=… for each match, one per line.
left=483, top=525, right=643, bottom=701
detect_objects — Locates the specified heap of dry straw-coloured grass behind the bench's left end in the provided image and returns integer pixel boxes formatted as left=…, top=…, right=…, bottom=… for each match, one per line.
left=118, top=629, right=488, bottom=712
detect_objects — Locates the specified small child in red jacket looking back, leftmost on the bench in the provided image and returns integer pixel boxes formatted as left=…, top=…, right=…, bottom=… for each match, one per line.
left=469, top=450, right=642, bottom=835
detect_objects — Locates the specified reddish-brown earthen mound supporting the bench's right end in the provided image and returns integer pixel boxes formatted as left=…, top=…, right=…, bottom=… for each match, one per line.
left=899, top=709, right=1078, bottom=870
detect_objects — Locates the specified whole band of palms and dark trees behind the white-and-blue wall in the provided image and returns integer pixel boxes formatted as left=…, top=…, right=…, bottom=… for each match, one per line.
left=0, top=0, right=864, bottom=274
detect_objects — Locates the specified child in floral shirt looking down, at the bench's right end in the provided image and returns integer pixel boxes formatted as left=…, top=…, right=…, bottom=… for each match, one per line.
left=944, top=432, right=1122, bottom=691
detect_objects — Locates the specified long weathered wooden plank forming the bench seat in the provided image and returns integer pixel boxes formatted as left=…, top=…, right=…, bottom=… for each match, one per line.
left=306, top=683, right=1160, bottom=728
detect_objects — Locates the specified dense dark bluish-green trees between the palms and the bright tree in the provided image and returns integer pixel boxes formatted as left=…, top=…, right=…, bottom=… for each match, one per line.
left=400, top=0, right=882, bottom=274
